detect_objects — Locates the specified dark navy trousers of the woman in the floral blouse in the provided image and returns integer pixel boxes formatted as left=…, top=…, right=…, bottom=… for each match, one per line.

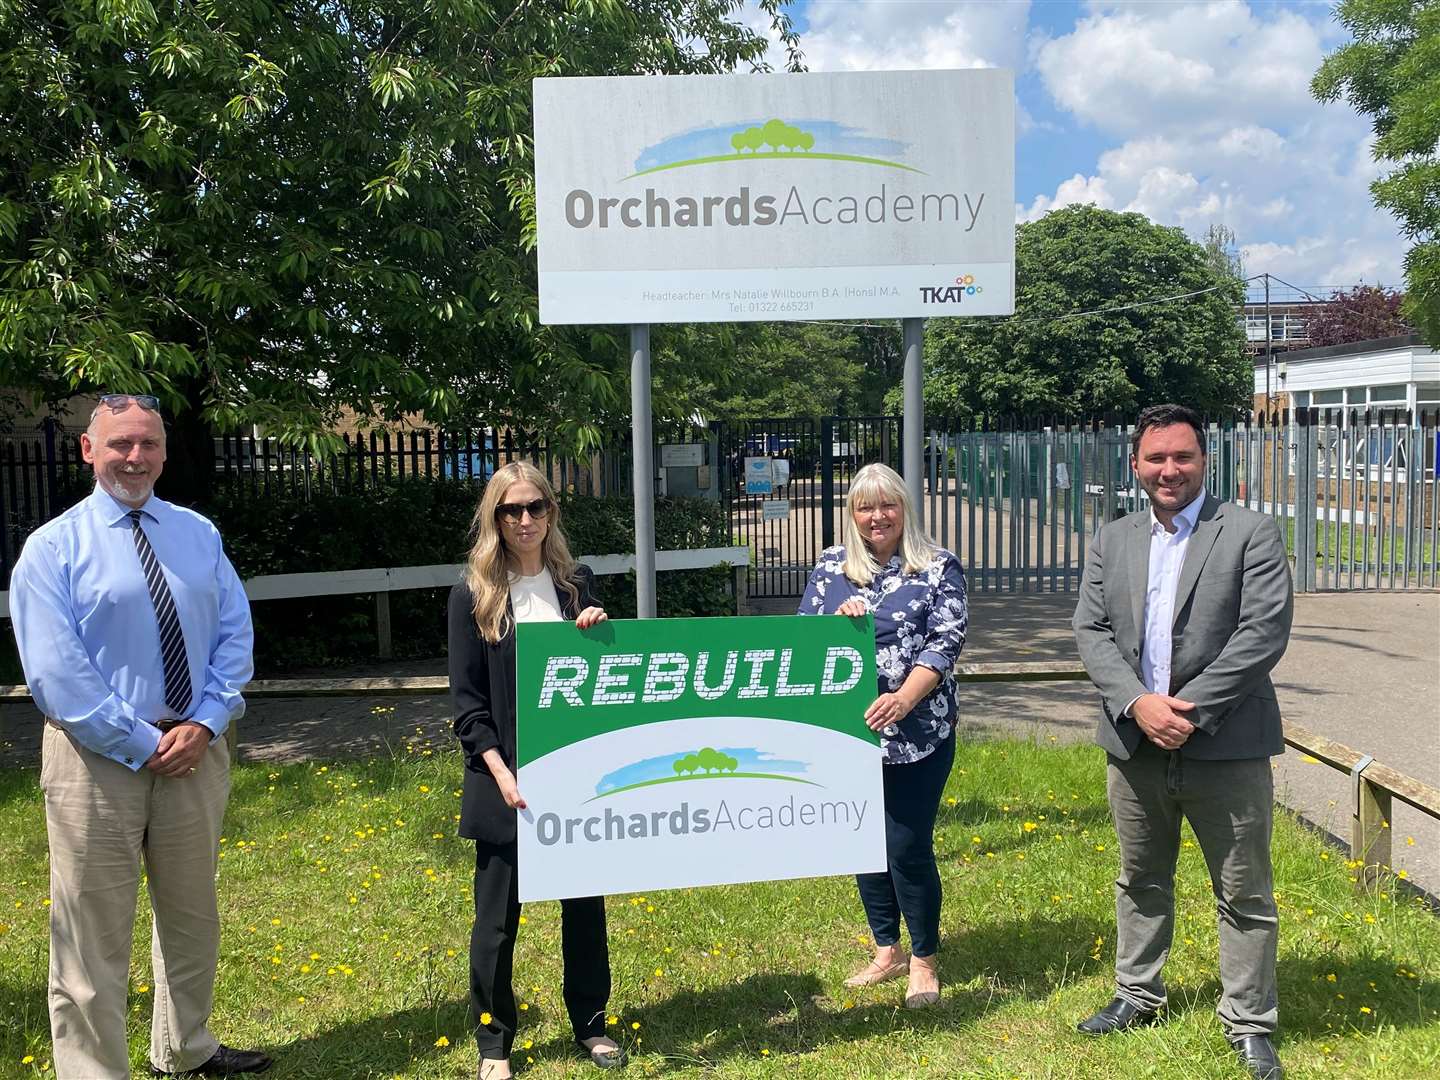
left=855, top=734, right=955, bottom=958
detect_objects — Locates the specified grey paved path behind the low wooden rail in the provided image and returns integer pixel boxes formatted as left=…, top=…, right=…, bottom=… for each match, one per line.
left=0, top=592, right=1440, bottom=894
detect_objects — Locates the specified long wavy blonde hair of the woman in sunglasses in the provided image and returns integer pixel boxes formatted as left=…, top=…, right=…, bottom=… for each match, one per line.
left=465, top=461, right=580, bottom=645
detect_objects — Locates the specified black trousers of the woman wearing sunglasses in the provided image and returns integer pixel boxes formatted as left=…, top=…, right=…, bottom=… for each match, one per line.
left=469, top=841, right=611, bottom=1057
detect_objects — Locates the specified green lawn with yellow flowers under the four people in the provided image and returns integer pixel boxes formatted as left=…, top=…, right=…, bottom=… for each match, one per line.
left=0, top=742, right=1440, bottom=1080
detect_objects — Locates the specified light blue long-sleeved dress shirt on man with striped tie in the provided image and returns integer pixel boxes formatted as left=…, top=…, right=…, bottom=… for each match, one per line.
left=10, top=485, right=255, bottom=769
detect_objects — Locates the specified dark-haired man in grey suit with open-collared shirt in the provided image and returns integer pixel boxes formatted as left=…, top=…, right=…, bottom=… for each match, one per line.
left=1074, top=405, right=1293, bottom=1080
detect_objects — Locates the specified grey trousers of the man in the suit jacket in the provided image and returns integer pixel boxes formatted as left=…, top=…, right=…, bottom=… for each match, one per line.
left=1107, top=742, right=1280, bottom=1038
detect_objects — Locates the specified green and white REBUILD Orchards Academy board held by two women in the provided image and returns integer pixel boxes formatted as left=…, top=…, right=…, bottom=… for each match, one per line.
left=516, top=616, right=886, bottom=901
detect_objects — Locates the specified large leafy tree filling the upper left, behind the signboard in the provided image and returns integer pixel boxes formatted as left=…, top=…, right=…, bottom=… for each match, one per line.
left=0, top=0, right=799, bottom=501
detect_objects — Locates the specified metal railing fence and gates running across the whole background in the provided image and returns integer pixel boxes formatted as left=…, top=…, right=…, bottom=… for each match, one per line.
left=0, top=409, right=1440, bottom=598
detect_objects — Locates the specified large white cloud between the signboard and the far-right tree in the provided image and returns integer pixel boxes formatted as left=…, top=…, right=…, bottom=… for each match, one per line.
left=1017, top=1, right=1405, bottom=285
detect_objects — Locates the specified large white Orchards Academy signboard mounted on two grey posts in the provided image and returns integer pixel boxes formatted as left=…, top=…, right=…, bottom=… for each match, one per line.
left=534, top=69, right=1015, bottom=323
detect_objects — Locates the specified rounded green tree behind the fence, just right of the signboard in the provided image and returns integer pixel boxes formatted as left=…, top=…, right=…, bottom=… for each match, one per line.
left=915, top=206, right=1253, bottom=420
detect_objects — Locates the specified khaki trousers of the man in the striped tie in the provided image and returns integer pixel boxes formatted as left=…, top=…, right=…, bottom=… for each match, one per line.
left=40, top=724, right=230, bottom=1080
